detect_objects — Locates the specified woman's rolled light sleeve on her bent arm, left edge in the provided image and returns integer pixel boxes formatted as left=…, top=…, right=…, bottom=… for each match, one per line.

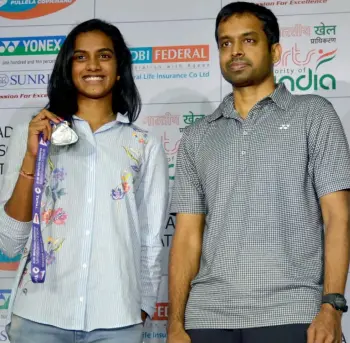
left=0, top=124, right=31, bottom=257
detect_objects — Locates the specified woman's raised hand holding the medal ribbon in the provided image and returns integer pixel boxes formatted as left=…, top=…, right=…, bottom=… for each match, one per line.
left=26, top=109, right=61, bottom=158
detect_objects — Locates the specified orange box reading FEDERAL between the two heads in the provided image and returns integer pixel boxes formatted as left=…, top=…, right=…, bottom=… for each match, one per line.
left=152, top=45, right=209, bottom=63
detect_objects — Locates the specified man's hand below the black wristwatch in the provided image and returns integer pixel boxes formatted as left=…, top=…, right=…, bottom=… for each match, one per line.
left=307, top=304, right=342, bottom=343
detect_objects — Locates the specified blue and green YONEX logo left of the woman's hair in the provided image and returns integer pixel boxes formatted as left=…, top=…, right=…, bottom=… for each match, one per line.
left=0, top=35, right=66, bottom=57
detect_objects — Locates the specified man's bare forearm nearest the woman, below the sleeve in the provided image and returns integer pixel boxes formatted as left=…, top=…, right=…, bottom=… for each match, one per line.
left=168, top=213, right=205, bottom=332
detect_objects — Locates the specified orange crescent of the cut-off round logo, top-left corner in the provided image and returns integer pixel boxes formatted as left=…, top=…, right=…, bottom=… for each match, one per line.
left=0, top=0, right=76, bottom=20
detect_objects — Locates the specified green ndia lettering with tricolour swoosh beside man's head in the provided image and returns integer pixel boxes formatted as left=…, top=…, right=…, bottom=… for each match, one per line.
left=275, top=49, right=337, bottom=91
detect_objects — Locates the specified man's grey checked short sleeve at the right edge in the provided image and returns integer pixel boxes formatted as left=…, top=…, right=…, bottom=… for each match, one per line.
left=308, top=97, right=350, bottom=198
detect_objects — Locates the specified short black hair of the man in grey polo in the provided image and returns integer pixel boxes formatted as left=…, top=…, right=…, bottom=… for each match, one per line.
left=215, top=1, right=280, bottom=48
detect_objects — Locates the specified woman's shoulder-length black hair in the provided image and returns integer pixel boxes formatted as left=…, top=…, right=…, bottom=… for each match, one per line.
left=46, top=19, right=141, bottom=123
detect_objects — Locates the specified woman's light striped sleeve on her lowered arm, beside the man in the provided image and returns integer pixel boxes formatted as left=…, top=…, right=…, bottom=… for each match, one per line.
left=136, top=136, right=169, bottom=317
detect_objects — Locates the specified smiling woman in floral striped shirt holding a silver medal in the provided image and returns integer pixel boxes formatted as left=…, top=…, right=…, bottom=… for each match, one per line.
left=0, top=19, right=168, bottom=343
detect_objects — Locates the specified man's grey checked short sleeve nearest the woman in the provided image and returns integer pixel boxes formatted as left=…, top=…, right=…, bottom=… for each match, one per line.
left=170, top=128, right=206, bottom=213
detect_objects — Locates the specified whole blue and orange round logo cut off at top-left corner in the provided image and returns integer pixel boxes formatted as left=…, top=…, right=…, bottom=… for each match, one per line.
left=0, top=0, right=76, bottom=20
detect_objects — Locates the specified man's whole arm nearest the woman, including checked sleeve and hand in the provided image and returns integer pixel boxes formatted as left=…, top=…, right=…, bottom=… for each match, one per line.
left=167, top=126, right=207, bottom=343
